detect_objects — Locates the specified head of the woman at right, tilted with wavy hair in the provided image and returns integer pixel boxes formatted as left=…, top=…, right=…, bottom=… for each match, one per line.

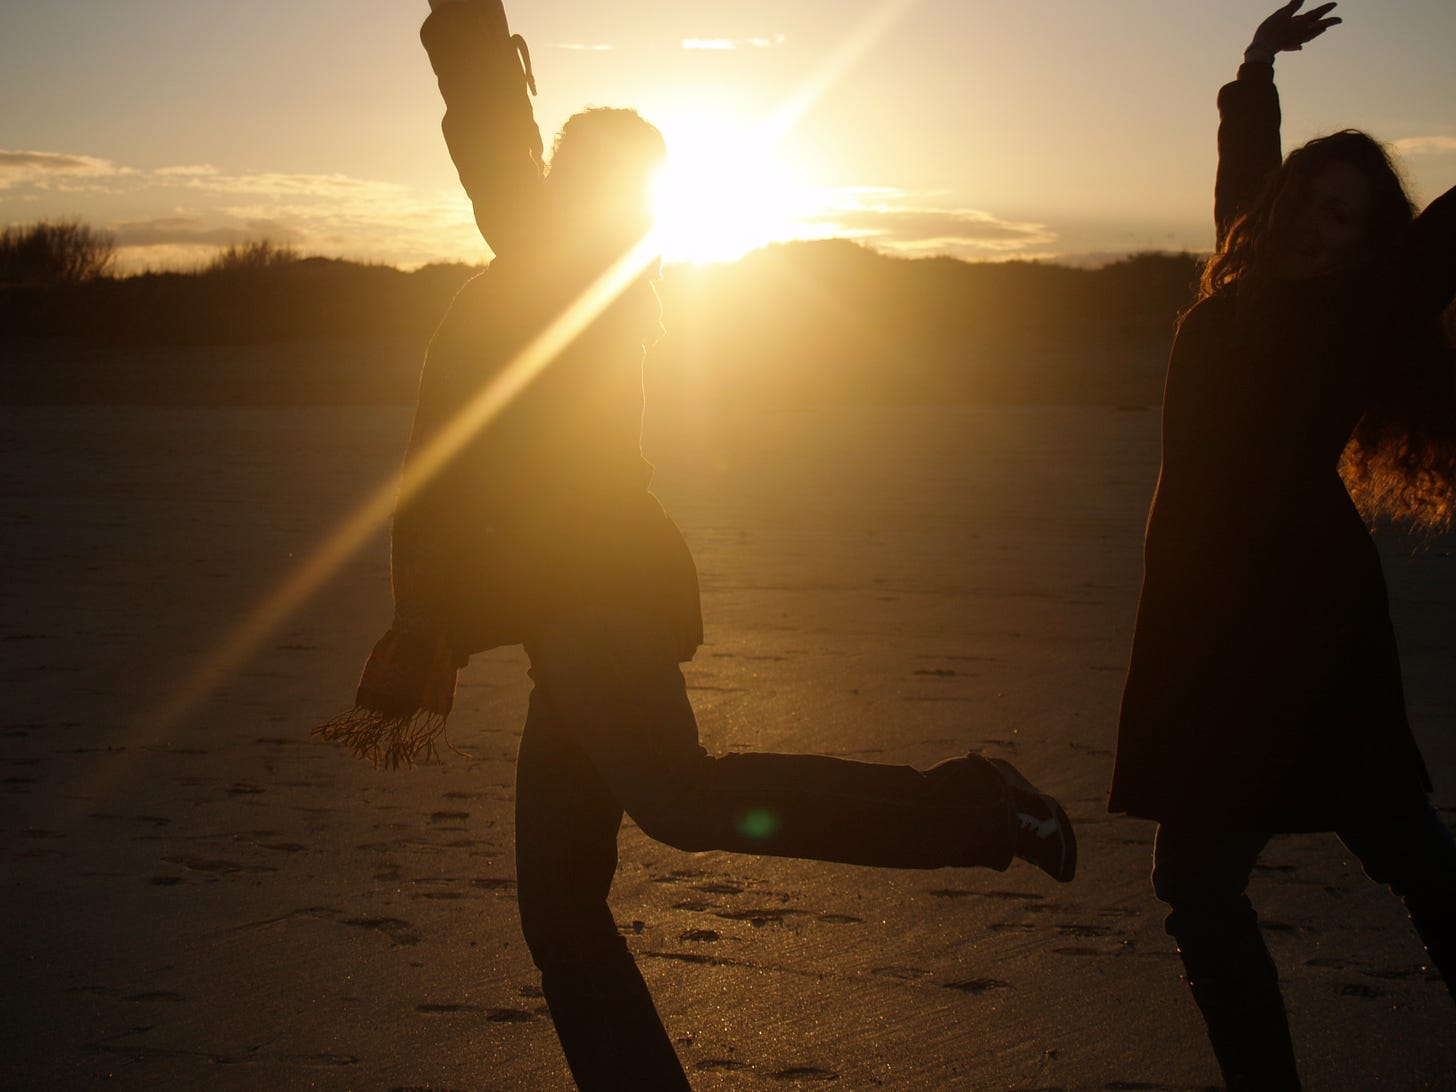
left=1203, top=130, right=1415, bottom=296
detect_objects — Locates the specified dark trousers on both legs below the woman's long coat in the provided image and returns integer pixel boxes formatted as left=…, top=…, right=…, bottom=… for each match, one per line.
left=1153, top=799, right=1456, bottom=1089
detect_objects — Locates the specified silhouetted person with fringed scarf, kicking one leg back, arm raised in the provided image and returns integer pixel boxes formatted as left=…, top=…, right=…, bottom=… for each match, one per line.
left=320, top=0, right=1076, bottom=1092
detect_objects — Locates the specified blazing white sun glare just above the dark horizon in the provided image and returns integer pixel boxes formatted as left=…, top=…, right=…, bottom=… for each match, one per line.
left=654, top=121, right=807, bottom=262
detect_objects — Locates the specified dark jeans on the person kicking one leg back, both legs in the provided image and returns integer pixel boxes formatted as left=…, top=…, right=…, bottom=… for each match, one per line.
left=515, top=612, right=1015, bottom=1089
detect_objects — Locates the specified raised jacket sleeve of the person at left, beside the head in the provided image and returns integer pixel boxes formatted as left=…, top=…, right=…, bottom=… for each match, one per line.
left=419, top=3, right=543, bottom=255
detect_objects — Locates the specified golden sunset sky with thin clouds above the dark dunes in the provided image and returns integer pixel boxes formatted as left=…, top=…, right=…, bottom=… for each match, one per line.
left=0, top=0, right=1456, bottom=271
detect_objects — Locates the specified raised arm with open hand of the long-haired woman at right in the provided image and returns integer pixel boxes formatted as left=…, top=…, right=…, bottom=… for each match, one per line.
left=1213, top=0, right=1340, bottom=250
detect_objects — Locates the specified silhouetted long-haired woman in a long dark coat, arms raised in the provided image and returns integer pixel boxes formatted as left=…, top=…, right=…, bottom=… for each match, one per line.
left=1109, top=0, right=1456, bottom=1088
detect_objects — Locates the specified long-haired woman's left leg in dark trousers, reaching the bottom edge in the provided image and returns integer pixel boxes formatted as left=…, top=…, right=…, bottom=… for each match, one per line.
left=1153, top=824, right=1299, bottom=1089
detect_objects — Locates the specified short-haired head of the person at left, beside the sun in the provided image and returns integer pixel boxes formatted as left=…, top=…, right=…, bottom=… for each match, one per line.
left=546, top=106, right=667, bottom=246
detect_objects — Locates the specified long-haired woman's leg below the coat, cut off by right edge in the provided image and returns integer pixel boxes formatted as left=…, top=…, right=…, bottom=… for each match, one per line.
left=1340, top=796, right=1456, bottom=999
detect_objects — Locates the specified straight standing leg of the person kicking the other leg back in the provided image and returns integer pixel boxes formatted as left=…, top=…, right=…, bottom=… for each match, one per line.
left=515, top=693, right=689, bottom=1092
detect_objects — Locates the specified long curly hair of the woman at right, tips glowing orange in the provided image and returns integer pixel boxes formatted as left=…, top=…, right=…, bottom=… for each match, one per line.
left=1198, top=130, right=1456, bottom=533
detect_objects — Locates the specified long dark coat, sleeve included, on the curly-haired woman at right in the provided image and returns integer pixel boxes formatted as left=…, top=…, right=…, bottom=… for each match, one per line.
left=1108, top=66, right=1456, bottom=831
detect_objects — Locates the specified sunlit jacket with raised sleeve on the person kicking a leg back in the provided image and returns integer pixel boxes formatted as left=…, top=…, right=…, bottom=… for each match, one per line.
left=392, top=4, right=702, bottom=660
